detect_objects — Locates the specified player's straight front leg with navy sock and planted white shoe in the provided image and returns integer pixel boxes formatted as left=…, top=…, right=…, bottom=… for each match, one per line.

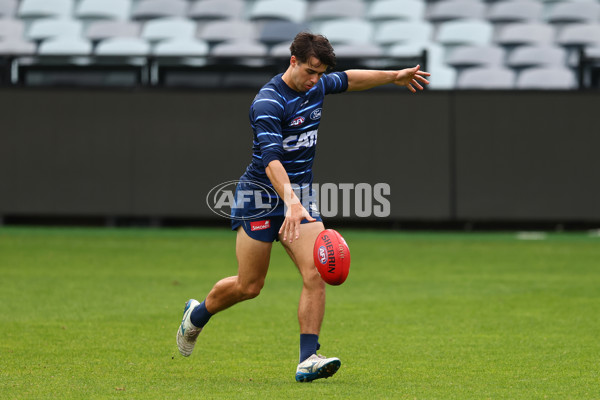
left=280, top=222, right=341, bottom=382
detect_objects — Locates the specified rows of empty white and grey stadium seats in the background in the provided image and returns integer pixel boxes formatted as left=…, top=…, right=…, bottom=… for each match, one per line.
left=0, top=0, right=600, bottom=89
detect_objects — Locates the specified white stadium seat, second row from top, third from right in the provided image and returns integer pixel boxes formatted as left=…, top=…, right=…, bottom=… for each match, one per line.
left=436, top=20, right=493, bottom=46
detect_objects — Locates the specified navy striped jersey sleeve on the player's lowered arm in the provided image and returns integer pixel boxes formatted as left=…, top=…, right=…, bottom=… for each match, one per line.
left=250, top=98, right=284, bottom=168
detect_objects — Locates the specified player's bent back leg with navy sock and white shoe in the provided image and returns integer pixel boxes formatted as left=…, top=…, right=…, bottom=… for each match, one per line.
left=177, top=227, right=272, bottom=357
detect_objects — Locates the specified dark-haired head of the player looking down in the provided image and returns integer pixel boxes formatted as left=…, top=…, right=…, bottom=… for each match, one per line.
left=286, top=32, right=335, bottom=92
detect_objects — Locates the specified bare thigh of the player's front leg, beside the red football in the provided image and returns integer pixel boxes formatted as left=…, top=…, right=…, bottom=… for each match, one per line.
left=279, top=221, right=325, bottom=279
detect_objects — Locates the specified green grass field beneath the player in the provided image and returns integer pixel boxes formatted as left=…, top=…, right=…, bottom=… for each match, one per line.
left=0, top=227, right=600, bottom=400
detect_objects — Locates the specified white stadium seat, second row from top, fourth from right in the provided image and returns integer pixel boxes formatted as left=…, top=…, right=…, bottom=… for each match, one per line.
left=373, top=21, right=433, bottom=45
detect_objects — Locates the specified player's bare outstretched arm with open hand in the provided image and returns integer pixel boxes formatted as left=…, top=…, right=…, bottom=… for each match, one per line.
left=346, top=65, right=431, bottom=93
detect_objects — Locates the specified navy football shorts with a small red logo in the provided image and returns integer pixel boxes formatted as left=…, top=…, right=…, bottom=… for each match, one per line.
left=231, top=182, right=323, bottom=243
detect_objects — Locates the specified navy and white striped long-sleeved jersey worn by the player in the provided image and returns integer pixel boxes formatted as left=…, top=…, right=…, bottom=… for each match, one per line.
left=242, top=72, right=348, bottom=186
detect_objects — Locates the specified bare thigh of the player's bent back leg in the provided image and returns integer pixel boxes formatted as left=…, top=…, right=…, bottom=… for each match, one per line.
left=235, top=227, right=273, bottom=286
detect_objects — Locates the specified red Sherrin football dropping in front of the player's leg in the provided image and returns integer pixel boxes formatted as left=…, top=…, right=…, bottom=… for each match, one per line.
left=313, top=229, right=350, bottom=285
